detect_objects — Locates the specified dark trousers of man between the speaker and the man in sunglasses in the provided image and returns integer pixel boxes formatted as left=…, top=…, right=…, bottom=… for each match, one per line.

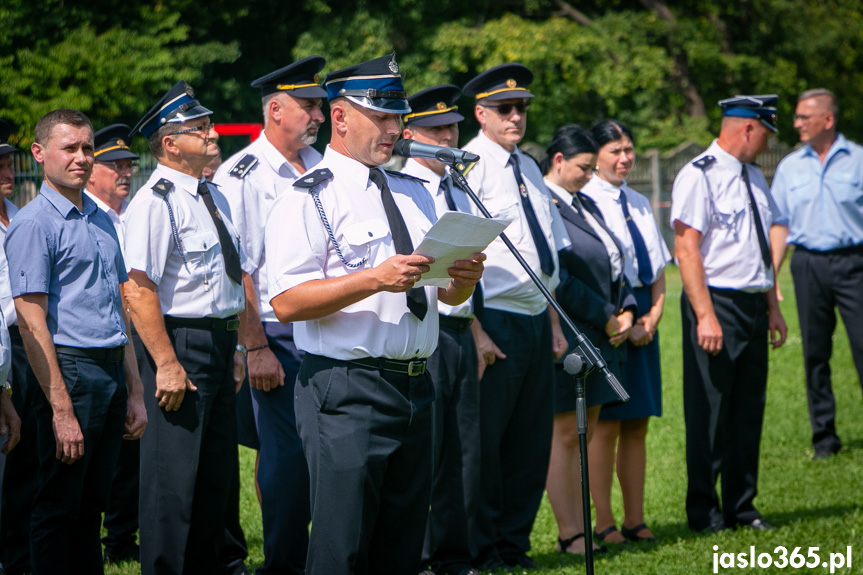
left=423, top=326, right=480, bottom=573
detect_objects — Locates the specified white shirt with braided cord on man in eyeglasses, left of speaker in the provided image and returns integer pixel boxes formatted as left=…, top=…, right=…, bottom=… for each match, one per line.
left=125, top=164, right=245, bottom=318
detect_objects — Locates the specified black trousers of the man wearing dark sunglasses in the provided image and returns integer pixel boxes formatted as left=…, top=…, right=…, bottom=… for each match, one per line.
left=476, top=308, right=554, bottom=563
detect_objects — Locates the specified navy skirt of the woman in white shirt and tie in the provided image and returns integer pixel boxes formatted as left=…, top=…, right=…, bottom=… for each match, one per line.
left=599, top=286, right=662, bottom=421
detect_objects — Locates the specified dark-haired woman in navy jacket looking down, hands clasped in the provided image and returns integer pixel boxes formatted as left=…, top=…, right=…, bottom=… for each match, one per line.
left=542, top=125, right=636, bottom=554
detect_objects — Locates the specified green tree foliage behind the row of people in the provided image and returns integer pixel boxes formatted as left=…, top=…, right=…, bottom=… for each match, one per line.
left=0, top=0, right=863, bottom=150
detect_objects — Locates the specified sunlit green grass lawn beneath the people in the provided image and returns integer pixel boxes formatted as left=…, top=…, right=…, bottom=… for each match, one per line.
left=106, top=268, right=863, bottom=575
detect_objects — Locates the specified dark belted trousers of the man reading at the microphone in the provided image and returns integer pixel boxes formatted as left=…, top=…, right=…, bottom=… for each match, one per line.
left=295, top=354, right=434, bottom=575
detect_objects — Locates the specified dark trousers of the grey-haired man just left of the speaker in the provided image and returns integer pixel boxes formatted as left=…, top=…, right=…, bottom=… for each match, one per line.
left=252, top=322, right=311, bottom=575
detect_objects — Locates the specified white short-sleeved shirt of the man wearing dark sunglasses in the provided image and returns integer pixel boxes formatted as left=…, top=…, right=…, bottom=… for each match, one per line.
left=464, top=131, right=570, bottom=315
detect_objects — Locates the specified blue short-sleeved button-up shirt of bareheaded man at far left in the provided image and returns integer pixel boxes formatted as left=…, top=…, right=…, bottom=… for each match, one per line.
left=5, top=182, right=129, bottom=348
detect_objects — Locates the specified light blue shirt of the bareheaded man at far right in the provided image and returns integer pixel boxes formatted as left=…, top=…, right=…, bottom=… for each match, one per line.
left=771, top=134, right=863, bottom=251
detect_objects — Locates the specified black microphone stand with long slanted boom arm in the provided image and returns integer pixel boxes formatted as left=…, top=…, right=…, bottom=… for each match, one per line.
left=444, top=159, right=629, bottom=575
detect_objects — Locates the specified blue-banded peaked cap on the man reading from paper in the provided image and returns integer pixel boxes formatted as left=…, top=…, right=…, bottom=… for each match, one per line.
left=324, top=52, right=411, bottom=114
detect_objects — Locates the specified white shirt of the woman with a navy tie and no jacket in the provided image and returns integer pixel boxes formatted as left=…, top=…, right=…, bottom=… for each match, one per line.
left=581, top=177, right=671, bottom=287
